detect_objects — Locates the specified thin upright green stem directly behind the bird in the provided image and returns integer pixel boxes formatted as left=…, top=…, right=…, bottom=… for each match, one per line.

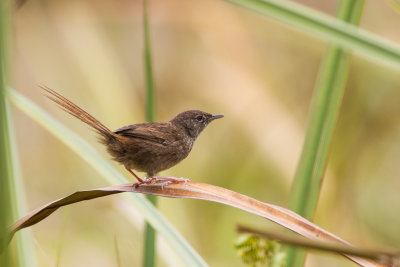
left=143, top=0, right=157, bottom=267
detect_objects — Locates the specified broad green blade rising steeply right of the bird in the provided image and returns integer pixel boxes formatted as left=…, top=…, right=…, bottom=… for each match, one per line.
left=287, top=0, right=364, bottom=266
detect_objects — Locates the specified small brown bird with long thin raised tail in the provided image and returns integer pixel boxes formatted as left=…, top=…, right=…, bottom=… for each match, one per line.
left=40, top=86, right=223, bottom=184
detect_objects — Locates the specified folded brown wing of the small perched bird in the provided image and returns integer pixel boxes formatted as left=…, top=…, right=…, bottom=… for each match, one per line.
left=115, top=123, right=174, bottom=145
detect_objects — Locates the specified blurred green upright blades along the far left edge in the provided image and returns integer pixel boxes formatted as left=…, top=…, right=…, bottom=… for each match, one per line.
left=0, top=1, right=37, bottom=266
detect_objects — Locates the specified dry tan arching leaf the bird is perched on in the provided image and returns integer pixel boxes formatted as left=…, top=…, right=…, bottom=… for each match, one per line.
left=9, top=180, right=383, bottom=266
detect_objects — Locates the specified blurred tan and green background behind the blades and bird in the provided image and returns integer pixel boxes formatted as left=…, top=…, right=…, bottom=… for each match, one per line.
left=7, top=0, right=400, bottom=267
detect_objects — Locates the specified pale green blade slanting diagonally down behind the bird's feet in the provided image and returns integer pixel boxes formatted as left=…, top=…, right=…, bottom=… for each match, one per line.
left=7, top=88, right=208, bottom=266
